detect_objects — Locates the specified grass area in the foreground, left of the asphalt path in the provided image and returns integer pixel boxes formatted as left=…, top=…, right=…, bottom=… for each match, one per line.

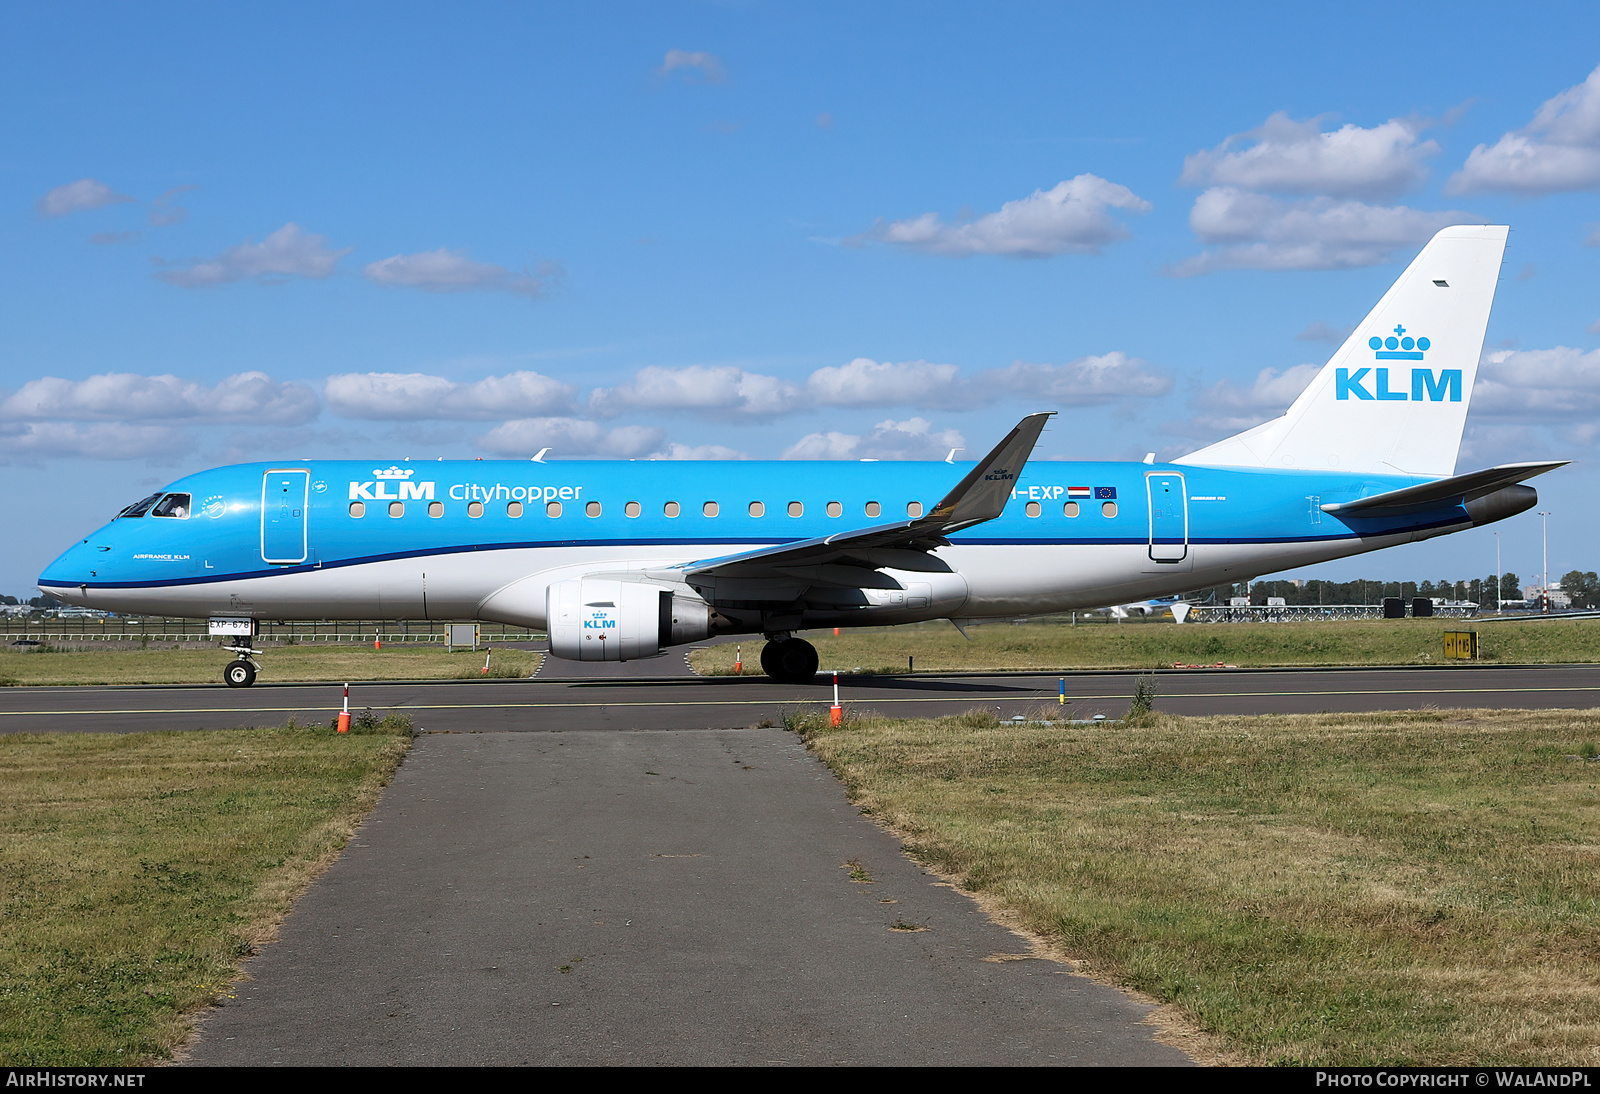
left=0, top=720, right=410, bottom=1067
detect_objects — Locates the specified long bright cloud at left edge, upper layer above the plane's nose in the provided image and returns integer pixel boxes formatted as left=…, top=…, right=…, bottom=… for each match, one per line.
left=0, top=373, right=317, bottom=425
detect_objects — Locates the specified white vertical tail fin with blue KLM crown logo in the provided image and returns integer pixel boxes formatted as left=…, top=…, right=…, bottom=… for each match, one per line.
left=1173, top=224, right=1509, bottom=477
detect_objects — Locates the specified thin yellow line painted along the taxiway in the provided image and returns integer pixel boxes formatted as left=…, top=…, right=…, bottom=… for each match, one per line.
left=9, top=686, right=1600, bottom=718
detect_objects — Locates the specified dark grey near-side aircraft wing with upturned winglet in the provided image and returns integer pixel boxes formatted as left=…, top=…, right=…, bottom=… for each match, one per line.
left=680, top=413, right=1050, bottom=600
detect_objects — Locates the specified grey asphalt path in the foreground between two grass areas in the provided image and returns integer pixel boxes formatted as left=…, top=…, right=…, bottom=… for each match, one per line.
left=192, top=729, right=1187, bottom=1065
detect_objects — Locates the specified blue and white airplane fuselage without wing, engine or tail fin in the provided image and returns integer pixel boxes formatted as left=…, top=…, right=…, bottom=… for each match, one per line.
left=38, top=461, right=1472, bottom=625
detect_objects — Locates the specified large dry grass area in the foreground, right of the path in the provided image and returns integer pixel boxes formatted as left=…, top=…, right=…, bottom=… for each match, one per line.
left=795, top=701, right=1600, bottom=1067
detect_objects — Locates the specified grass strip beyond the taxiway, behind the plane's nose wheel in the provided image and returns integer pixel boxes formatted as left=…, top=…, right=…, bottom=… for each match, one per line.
left=0, top=643, right=544, bottom=686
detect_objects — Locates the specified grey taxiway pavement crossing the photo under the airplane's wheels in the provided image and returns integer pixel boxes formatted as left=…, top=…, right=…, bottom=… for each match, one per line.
left=0, top=662, right=1600, bottom=733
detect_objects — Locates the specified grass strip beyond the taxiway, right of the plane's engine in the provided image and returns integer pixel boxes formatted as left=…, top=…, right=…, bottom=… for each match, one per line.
left=690, top=619, right=1600, bottom=675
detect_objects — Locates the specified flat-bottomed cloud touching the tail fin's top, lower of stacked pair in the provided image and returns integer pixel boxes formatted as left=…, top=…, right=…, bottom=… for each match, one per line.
left=1170, top=186, right=1485, bottom=277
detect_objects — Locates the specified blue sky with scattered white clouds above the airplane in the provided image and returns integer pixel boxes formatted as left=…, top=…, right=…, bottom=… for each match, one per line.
left=0, top=3, right=1600, bottom=595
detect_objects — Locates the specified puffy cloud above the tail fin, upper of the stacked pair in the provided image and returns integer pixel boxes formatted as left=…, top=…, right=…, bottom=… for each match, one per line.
left=1179, top=112, right=1438, bottom=198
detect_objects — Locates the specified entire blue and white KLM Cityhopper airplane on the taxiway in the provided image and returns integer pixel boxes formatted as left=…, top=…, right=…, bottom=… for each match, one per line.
left=38, top=226, right=1562, bottom=686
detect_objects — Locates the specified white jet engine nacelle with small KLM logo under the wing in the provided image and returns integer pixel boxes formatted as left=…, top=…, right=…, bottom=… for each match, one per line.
left=544, top=577, right=710, bottom=661
